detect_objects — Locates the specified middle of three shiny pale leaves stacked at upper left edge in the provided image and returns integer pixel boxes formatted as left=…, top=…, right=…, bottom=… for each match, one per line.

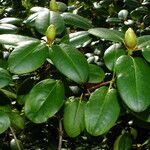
left=0, top=23, right=18, bottom=34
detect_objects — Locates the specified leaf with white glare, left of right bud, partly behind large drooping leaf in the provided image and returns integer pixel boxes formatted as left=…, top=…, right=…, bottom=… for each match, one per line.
left=104, top=44, right=125, bottom=71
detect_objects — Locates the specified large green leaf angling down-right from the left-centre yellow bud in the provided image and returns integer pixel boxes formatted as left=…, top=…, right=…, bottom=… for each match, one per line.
left=50, top=44, right=89, bottom=83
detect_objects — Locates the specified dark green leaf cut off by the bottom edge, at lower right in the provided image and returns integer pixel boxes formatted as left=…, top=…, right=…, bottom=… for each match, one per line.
left=113, top=133, right=132, bottom=150
